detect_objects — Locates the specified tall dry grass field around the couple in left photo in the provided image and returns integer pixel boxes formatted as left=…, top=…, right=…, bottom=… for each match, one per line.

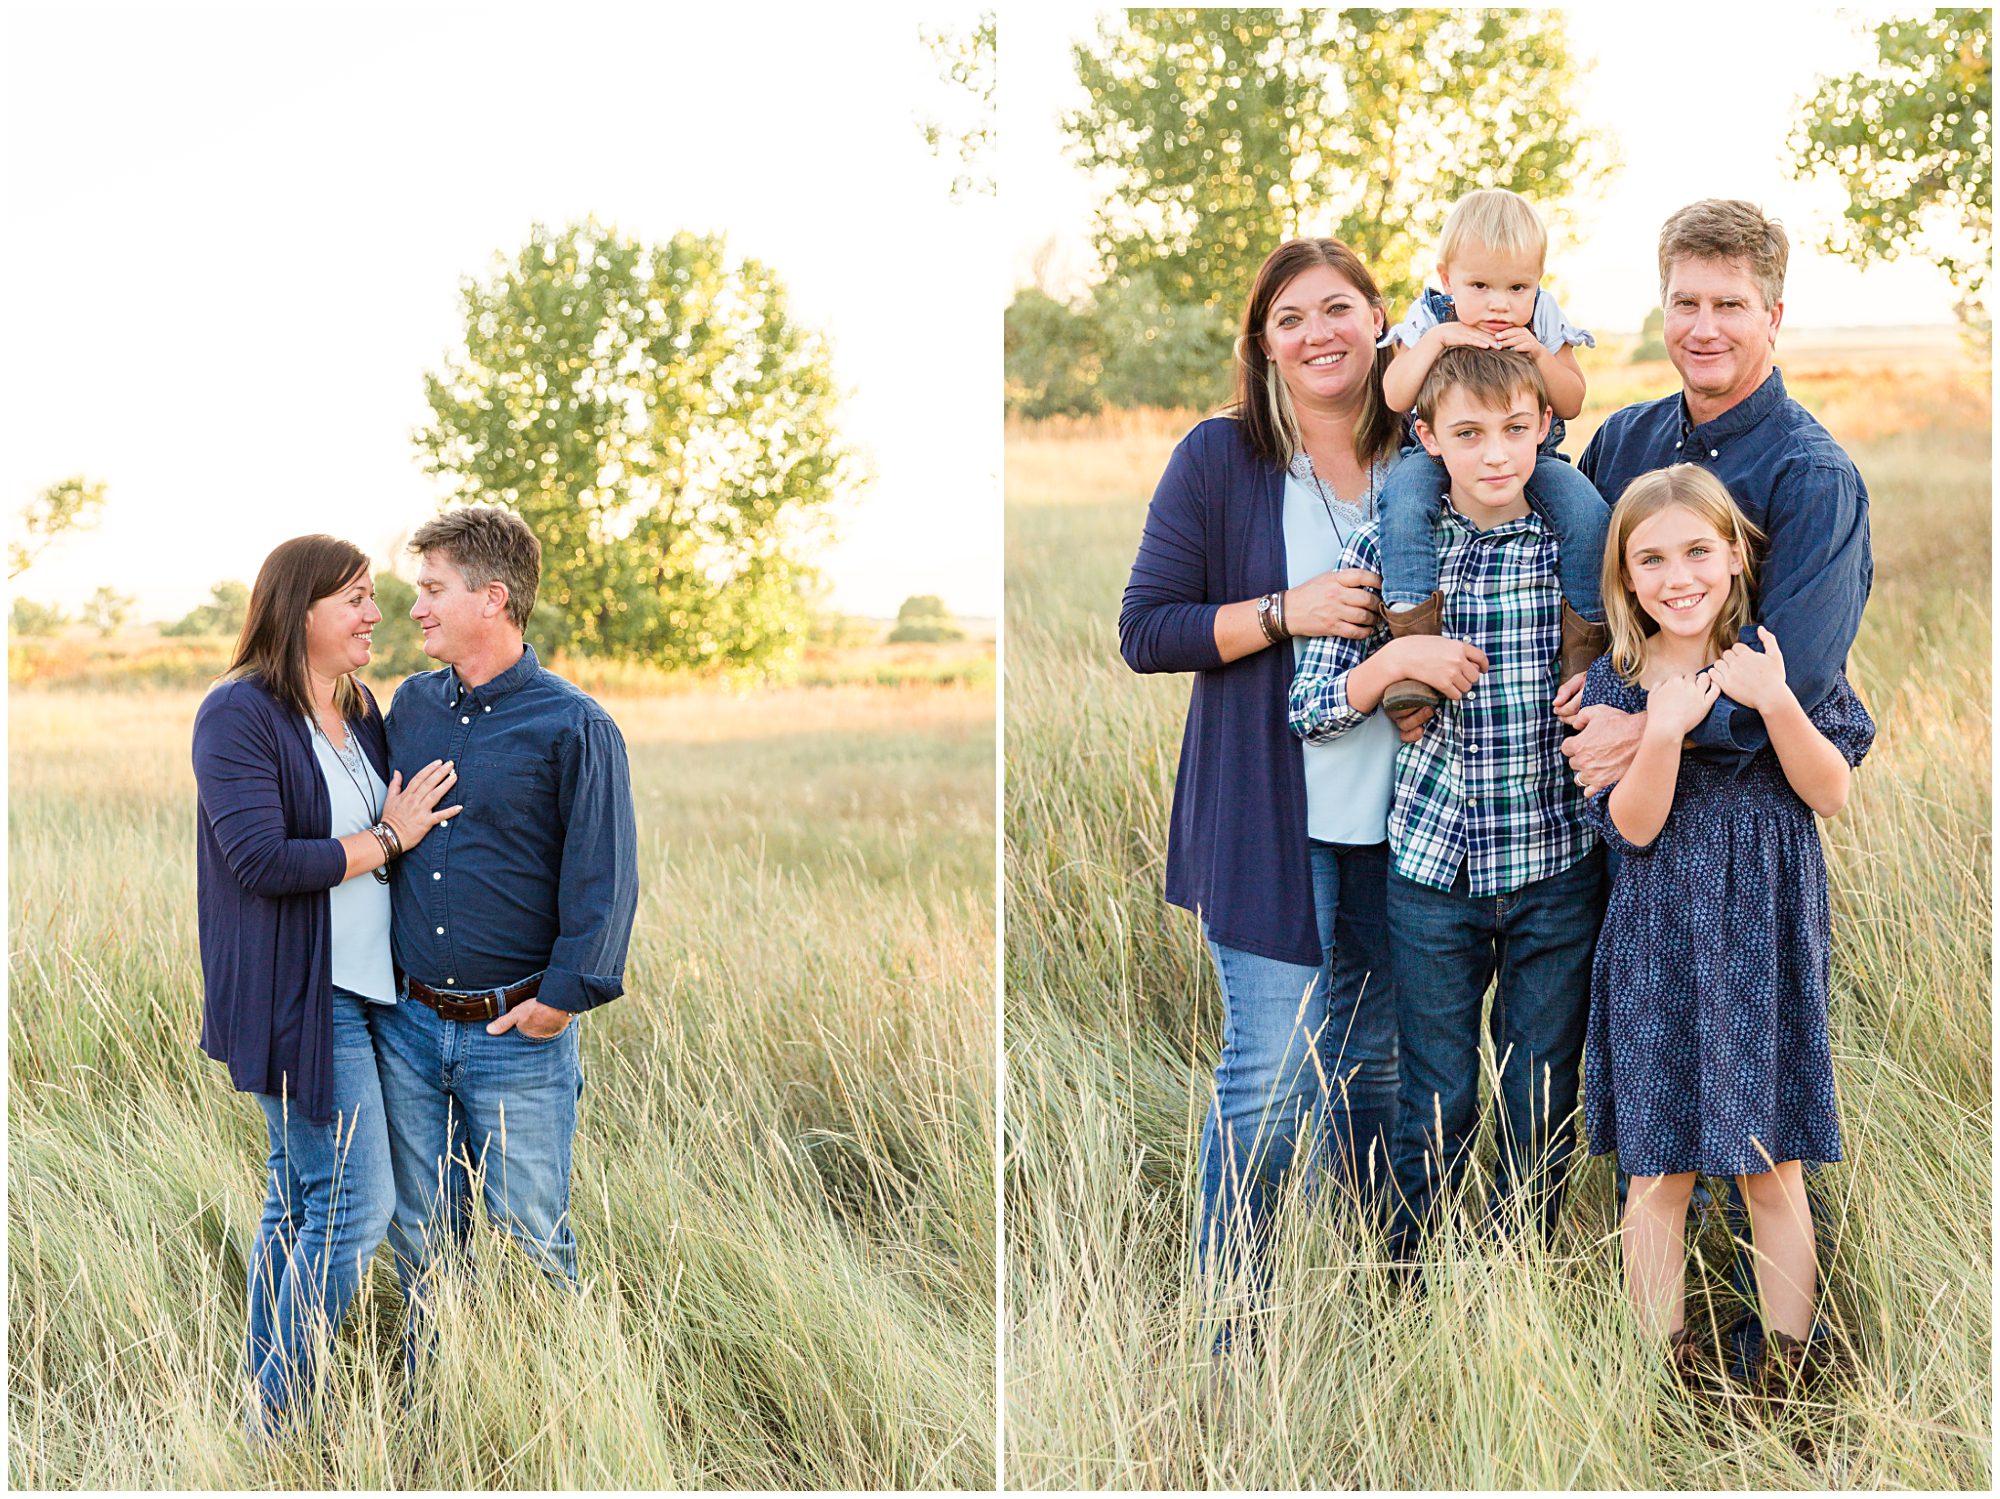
left=8, top=688, right=994, bottom=1489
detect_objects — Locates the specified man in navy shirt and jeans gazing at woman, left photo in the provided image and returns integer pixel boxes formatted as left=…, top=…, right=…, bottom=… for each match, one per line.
left=376, top=508, right=638, bottom=1349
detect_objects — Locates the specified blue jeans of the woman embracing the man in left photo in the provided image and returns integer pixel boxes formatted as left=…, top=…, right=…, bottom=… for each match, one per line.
left=246, top=989, right=396, bottom=1435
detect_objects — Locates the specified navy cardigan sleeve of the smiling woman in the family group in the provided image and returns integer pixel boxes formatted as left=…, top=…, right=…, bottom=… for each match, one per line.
left=1118, top=440, right=1222, bottom=672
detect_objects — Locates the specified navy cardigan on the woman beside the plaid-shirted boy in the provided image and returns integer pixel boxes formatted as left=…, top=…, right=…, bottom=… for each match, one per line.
left=1118, top=416, right=1322, bottom=967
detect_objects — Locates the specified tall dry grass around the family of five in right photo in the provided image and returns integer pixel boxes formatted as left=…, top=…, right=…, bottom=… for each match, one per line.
left=1006, top=368, right=1992, bottom=1489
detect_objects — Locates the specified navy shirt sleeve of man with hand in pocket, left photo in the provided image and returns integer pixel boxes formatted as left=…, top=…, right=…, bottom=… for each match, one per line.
left=536, top=718, right=638, bottom=1011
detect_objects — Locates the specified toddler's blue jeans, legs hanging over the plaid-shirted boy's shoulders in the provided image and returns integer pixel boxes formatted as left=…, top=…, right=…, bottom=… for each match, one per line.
left=1378, top=448, right=1612, bottom=624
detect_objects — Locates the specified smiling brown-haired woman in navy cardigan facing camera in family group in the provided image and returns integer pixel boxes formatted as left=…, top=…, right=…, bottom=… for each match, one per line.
left=1118, top=240, right=1480, bottom=1295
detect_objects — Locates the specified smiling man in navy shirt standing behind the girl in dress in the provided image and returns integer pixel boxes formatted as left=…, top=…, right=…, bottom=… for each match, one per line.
left=1556, top=198, right=1874, bottom=1377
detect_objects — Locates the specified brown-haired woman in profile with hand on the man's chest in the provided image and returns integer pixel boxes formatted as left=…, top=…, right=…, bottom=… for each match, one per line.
left=194, top=536, right=458, bottom=1435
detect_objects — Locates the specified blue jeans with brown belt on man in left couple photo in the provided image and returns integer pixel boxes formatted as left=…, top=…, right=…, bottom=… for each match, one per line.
left=374, top=997, right=584, bottom=1353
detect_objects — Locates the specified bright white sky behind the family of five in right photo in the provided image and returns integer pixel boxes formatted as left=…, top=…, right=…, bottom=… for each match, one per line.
left=1000, top=2, right=1954, bottom=332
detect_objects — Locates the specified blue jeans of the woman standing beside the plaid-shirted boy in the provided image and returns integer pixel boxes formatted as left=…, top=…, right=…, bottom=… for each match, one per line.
left=1196, top=841, right=1396, bottom=1267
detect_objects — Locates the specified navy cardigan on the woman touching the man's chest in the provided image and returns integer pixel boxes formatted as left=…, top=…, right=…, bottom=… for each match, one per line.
left=194, top=680, right=388, bottom=1123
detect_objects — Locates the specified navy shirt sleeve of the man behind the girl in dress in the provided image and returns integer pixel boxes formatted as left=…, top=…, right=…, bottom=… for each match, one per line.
left=1694, top=462, right=1872, bottom=765
